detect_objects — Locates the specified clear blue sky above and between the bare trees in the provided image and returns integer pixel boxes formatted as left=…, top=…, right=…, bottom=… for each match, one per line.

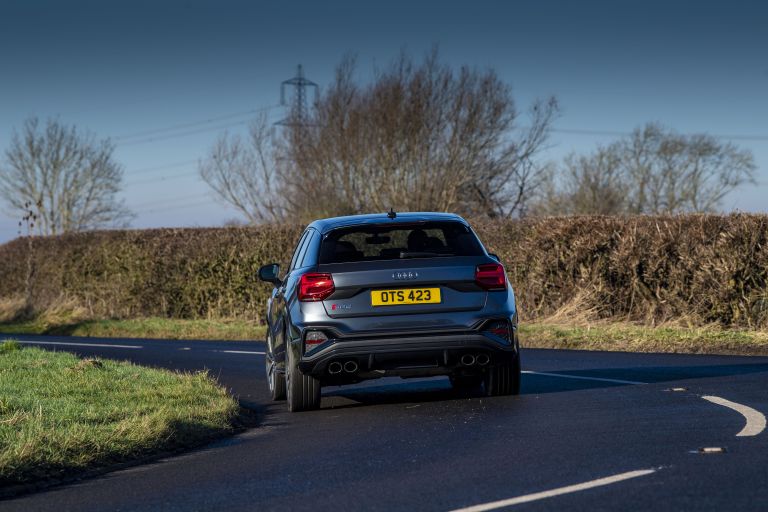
left=0, top=0, right=768, bottom=242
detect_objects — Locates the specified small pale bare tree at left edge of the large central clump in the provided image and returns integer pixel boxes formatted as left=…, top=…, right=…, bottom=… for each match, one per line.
left=199, top=115, right=284, bottom=223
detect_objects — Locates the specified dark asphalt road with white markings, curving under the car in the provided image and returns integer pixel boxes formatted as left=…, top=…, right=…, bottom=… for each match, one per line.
left=0, top=336, right=768, bottom=512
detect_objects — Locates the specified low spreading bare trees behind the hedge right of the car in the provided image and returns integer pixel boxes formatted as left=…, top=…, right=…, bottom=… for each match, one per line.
left=536, top=123, right=755, bottom=214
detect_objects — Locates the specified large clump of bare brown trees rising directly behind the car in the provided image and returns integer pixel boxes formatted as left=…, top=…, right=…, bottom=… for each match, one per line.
left=201, top=51, right=558, bottom=222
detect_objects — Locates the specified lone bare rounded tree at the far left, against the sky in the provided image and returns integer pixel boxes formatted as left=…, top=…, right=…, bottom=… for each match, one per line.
left=0, top=118, right=132, bottom=235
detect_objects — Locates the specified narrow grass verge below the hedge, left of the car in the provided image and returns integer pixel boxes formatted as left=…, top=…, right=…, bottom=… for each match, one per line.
left=0, top=318, right=266, bottom=340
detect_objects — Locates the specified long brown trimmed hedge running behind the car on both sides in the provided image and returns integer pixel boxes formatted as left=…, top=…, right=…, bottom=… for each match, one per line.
left=0, top=214, right=768, bottom=328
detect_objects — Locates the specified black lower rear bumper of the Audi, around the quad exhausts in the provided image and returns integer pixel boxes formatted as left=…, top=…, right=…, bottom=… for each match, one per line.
left=299, top=331, right=518, bottom=381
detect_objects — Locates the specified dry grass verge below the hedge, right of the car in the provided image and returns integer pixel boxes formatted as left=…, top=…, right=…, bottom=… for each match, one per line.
left=520, top=323, right=768, bottom=355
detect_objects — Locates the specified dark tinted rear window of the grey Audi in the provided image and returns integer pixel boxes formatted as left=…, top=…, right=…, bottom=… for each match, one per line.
left=319, top=222, right=483, bottom=264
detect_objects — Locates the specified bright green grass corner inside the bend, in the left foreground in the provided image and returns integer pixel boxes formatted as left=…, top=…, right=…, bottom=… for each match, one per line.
left=0, top=341, right=239, bottom=487
